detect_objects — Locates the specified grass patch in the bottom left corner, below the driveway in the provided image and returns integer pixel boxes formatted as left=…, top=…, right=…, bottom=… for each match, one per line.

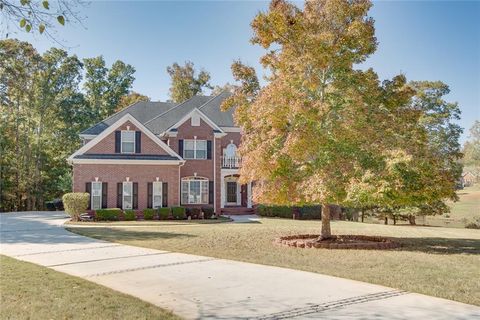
left=0, top=256, right=180, bottom=320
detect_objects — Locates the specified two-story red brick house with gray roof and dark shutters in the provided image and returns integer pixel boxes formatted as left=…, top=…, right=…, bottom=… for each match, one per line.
left=68, top=92, right=252, bottom=214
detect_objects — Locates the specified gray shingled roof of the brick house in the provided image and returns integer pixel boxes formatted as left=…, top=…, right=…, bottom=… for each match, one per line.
left=81, top=92, right=236, bottom=135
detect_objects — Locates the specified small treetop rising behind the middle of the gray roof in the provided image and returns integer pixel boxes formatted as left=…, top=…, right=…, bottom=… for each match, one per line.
left=167, top=61, right=212, bottom=103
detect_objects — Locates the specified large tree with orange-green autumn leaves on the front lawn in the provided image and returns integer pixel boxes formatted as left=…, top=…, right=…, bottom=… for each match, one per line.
left=223, top=0, right=456, bottom=240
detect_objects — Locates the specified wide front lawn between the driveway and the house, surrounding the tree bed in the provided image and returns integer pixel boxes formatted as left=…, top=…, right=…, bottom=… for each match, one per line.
left=67, top=219, right=480, bottom=305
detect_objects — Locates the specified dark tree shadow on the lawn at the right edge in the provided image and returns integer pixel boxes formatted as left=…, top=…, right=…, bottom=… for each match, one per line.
left=390, top=238, right=480, bottom=255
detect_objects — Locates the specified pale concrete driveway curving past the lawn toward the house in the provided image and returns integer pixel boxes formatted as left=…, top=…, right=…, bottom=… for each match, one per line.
left=0, top=212, right=480, bottom=319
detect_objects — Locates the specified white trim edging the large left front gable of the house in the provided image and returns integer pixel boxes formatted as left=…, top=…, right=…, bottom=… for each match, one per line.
left=67, top=113, right=183, bottom=163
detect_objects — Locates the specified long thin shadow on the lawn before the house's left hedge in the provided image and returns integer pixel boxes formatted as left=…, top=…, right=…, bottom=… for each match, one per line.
left=67, top=228, right=196, bottom=242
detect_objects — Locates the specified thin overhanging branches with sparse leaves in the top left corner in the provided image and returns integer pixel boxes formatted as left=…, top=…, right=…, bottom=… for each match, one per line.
left=0, top=0, right=80, bottom=38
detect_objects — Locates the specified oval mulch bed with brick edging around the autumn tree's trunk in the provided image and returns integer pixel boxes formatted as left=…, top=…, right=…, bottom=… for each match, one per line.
left=275, top=234, right=400, bottom=249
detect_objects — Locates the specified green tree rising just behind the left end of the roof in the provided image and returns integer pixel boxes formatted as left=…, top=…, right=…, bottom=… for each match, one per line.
left=83, top=56, right=135, bottom=124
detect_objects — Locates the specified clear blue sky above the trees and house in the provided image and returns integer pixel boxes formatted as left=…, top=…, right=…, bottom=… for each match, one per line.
left=11, top=1, right=480, bottom=142
